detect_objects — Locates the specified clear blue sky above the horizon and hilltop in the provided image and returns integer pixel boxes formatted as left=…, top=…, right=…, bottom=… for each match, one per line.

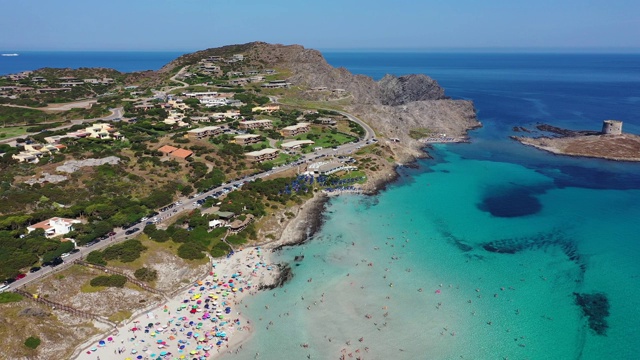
left=0, top=0, right=640, bottom=51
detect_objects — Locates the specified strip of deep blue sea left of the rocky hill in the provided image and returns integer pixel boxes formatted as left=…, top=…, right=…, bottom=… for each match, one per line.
left=0, top=51, right=185, bottom=75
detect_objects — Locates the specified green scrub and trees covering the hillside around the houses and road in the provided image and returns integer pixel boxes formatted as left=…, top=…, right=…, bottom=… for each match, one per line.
left=0, top=48, right=372, bottom=278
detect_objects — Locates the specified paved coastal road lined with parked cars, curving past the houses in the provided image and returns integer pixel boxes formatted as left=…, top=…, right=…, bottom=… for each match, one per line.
left=6, top=107, right=375, bottom=288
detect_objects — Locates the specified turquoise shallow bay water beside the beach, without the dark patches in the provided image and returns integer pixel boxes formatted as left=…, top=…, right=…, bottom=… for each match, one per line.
left=232, top=149, right=640, bottom=359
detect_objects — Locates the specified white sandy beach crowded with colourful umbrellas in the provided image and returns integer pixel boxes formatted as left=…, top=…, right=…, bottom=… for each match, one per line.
left=77, top=247, right=278, bottom=360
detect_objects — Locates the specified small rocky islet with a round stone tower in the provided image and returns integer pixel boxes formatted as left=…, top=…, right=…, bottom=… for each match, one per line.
left=511, top=120, right=640, bottom=161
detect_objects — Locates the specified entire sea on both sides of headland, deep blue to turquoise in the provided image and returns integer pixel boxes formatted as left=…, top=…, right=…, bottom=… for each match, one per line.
left=0, top=52, right=640, bottom=360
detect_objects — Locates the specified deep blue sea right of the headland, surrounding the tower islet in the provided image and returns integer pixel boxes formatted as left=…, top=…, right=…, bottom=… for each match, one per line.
left=324, top=52, right=640, bottom=189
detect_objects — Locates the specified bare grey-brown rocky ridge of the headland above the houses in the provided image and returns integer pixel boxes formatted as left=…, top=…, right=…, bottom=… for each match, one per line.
left=160, top=42, right=480, bottom=161
